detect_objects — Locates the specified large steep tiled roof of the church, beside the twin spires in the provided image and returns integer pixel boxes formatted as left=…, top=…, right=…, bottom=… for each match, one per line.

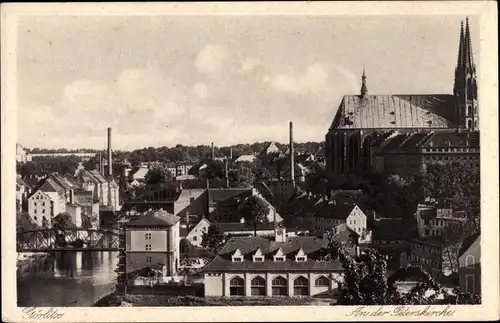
left=330, top=94, right=456, bottom=129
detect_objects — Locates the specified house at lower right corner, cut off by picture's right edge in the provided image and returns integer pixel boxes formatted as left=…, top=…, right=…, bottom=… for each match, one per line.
left=458, top=234, right=481, bottom=295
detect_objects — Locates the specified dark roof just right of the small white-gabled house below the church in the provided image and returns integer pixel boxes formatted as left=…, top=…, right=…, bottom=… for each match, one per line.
left=372, top=218, right=417, bottom=241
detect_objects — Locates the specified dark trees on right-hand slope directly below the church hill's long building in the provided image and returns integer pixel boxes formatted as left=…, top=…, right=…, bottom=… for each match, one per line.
left=422, top=163, right=480, bottom=211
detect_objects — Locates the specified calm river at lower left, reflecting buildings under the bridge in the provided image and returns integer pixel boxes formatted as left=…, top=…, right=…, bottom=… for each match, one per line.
left=17, top=251, right=118, bottom=307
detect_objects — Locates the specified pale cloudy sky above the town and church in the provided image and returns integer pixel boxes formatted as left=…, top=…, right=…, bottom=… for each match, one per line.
left=17, top=16, right=479, bottom=150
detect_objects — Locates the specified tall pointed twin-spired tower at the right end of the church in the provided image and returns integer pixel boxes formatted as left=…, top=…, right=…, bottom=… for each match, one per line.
left=453, top=18, right=479, bottom=130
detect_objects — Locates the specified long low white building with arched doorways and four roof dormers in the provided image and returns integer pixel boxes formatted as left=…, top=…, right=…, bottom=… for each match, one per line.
left=202, top=228, right=343, bottom=297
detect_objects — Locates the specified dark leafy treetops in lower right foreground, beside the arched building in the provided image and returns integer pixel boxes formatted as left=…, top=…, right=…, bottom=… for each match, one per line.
left=327, top=239, right=478, bottom=305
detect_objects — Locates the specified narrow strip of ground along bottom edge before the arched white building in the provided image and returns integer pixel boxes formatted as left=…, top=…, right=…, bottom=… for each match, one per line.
left=93, top=293, right=333, bottom=307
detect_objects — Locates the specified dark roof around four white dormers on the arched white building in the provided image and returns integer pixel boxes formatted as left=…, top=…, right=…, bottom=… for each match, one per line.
left=202, top=236, right=343, bottom=272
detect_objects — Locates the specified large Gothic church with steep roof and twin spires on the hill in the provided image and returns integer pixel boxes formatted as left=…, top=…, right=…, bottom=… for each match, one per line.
left=325, top=18, right=479, bottom=179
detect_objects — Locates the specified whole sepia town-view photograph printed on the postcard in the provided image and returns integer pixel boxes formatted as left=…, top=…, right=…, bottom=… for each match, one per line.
left=2, top=3, right=498, bottom=321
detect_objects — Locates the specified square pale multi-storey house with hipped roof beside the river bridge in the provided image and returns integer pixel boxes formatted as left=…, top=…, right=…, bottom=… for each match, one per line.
left=124, top=209, right=180, bottom=276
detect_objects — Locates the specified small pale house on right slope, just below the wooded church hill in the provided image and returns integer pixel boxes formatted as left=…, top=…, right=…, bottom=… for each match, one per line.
left=415, top=203, right=467, bottom=238
